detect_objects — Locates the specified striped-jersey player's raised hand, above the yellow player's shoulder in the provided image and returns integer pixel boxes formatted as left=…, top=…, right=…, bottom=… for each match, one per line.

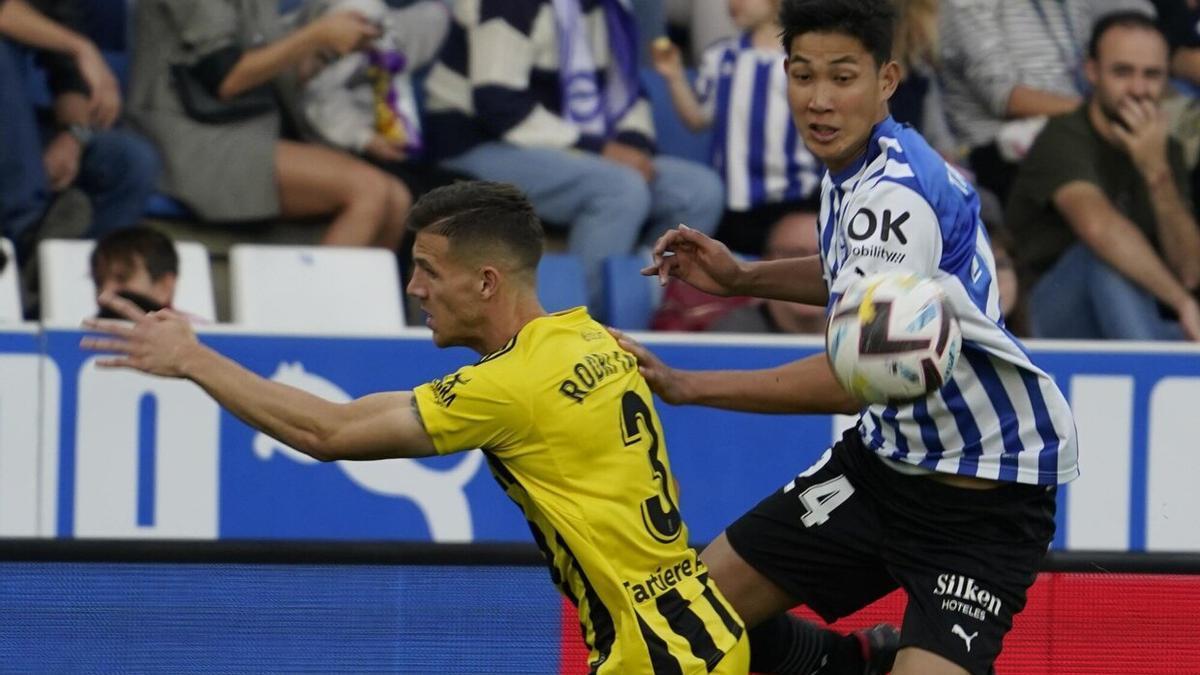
left=642, top=225, right=742, bottom=295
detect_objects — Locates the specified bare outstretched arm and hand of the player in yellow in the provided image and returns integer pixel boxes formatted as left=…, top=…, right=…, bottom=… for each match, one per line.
left=80, top=295, right=434, bottom=461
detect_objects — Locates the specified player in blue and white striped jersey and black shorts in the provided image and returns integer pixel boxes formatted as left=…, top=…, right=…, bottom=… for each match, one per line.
left=622, top=0, right=1078, bottom=675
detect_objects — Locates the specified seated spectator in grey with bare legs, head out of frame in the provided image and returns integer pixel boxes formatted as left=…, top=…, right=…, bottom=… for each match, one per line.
left=127, top=0, right=412, bottom=249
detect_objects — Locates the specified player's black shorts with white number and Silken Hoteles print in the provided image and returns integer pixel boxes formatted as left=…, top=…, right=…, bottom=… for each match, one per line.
left=726, top=429, right=1056, bottom=674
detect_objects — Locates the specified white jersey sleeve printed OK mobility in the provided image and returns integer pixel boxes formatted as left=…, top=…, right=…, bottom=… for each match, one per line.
left=829, top=180, right=942, bottom=295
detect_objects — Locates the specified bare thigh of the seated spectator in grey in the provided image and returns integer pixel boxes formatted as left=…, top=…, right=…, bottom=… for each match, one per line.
left=275, top=141, right=392, bottom=216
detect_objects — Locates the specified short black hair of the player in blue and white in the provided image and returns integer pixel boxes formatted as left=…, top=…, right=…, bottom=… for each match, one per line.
left=779, top=0, right=896, bottom=66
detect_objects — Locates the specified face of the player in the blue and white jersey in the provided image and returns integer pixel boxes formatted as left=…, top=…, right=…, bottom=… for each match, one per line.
left=784, top=32, right=900, bottom=171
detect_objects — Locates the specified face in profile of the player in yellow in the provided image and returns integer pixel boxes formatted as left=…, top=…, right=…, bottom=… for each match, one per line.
left=408, top=232, right=481, bottom=347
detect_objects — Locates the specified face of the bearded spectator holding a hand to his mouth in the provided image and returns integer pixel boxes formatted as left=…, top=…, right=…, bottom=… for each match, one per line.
left=1086, top=25, right=1168, bottom=123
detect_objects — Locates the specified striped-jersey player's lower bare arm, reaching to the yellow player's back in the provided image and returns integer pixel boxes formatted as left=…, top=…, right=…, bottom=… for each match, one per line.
left=608, top=328, right=863, bottom=414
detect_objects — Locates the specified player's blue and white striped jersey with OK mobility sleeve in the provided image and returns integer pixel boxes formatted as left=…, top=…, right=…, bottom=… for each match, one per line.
left=820, top=117, right=1079, bottom=485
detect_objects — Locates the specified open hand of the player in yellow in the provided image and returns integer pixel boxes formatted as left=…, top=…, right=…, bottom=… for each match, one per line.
left=79, top=293, right=199, bottom=377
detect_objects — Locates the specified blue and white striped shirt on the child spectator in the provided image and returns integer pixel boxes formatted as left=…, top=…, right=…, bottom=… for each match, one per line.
left=696, top=32, right=821, bottom=211
